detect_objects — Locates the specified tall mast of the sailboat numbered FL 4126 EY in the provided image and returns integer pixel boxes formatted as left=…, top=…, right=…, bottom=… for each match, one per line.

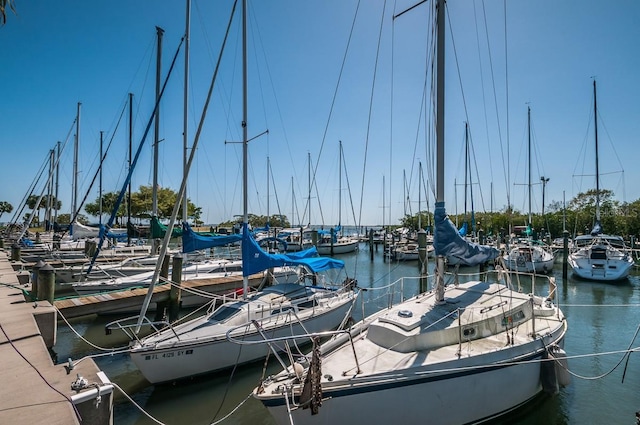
left=242, top=0, right=249, bottom=299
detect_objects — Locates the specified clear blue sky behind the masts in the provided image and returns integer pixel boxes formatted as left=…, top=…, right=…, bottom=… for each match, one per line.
left=0, top=0, right=640, bottom=226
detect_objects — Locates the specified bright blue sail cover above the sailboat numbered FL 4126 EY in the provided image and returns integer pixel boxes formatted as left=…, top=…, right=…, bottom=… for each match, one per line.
left=242, top=224, right=344, bottom=276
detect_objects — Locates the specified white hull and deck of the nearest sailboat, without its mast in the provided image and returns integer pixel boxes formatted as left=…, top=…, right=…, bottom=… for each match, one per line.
left=254, top=280, right=567, bottom=425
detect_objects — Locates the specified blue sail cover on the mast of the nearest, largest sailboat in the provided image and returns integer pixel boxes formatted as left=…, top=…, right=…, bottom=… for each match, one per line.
left=433, top=202, right=500, bottom=266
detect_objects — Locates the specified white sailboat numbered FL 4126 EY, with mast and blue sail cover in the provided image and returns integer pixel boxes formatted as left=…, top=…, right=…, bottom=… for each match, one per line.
left=109, top=0, right=356, bottom=384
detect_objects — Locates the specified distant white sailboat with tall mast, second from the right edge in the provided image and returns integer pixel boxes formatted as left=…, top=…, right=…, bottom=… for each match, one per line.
left=503, top=107, right=554, bottom=273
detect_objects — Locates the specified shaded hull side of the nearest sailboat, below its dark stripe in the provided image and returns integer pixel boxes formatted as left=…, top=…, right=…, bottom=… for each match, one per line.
left=265, top=344, right=556, bottom=425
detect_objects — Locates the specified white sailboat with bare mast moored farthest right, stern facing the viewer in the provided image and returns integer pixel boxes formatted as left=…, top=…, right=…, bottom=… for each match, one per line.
left=567, top=80, right=634, bottom=281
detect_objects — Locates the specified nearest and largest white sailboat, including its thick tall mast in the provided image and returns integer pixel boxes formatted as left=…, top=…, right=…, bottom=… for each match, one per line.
left=253, top=0, right=567, bottom=425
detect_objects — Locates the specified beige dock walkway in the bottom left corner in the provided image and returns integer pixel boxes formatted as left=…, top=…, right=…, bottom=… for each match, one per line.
left=0, top=249, right=113, bottom=425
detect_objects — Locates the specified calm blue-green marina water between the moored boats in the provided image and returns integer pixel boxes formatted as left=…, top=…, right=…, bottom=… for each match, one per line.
left=55, top=245, right=640, bottom=425
